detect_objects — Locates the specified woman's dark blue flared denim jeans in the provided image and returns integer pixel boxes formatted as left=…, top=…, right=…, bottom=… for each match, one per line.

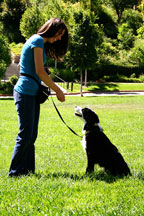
left=9, top=91, right=40, bottom=176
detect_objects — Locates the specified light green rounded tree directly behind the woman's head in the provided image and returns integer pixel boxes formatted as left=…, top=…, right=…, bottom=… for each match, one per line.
left=20, top=0, right=68, bottom=39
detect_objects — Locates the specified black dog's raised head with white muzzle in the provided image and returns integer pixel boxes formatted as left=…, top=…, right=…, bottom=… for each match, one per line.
left=75, top=106, right=100, bottom=130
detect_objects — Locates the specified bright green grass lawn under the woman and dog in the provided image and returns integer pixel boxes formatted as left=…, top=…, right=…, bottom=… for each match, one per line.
left=0, top=96, right=144, bottom=216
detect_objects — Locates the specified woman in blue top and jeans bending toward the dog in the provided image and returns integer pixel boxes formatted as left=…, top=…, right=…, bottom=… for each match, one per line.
left=9, top=18, right=68, bottom=176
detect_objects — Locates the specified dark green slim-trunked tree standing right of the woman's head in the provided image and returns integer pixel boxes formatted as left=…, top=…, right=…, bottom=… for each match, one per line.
left=68, top=11, right=102, bottom=94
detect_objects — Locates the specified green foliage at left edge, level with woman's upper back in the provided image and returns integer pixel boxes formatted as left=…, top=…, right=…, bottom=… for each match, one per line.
left=0, top=34, right=11, bottom=78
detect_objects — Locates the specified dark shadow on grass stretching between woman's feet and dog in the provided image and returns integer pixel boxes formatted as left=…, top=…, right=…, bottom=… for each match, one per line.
left=35, top=171, right=128, bottom=183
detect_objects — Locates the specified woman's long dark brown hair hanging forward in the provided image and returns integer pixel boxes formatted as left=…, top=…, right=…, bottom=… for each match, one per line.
left=37, top=18, right=68, bottom=60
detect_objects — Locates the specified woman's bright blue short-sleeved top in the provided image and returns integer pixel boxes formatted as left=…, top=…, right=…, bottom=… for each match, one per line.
left=14, top=34, right=46, bottom=95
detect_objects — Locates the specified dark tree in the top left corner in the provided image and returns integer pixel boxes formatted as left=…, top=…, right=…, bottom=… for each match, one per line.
left=0, top=0, right=30, bottom=43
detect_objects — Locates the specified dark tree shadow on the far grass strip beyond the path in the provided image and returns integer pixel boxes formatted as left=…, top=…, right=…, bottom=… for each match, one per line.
left=88, top=83, right=119, bottom=91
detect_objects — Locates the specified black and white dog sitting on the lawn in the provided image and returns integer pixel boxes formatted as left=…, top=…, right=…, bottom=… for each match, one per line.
left=75, top=106, right=130, bottom=176
